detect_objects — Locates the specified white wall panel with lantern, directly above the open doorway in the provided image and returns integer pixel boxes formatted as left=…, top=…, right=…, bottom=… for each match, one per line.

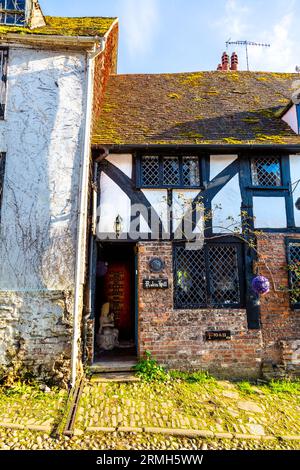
left=97, top=173, right=131, bottom=235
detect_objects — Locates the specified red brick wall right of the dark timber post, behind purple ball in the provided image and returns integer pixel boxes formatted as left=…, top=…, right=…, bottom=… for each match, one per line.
left=258, top=234, right=300, bottom=364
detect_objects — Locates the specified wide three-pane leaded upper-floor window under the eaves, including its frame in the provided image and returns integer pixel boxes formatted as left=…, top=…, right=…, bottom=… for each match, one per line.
left=138, top=155, right=200, bottom=188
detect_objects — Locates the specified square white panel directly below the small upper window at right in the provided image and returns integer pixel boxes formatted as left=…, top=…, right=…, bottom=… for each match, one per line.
left=253, top=196, right=287, bottom=228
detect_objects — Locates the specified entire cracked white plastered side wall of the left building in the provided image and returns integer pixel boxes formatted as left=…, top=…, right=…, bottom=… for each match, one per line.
left=0, top=48, right=86, bottom=380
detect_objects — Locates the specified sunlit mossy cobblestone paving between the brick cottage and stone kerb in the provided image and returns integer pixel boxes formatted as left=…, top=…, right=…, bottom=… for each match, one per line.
left=75, top=381, right=300, bottom=436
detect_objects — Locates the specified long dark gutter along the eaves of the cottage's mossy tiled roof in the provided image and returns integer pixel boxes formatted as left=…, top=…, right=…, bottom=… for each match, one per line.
left=92, top=143, right=300, bottom=154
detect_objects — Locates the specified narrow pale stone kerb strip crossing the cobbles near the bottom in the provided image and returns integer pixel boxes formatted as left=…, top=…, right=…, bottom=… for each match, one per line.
left=81, top=426, right=300, bottom=441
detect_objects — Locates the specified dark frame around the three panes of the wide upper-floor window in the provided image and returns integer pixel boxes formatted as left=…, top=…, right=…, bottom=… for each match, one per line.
left=135, top=153, right=204, bottom=190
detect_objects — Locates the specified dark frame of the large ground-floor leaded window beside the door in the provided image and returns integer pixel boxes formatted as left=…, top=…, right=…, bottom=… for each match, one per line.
left=173, top=236, right=246, bottom=310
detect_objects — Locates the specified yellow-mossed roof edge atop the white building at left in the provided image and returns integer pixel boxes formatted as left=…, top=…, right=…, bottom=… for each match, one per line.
left=0, top=16, right=116, bottom=36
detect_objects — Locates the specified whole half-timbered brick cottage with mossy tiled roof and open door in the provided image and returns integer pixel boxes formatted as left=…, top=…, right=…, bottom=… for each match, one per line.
left=89, top=63, right=300, bottom=376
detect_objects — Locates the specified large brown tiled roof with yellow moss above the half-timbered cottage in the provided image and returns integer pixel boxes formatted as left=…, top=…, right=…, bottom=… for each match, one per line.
left=93, top=72, right=300, bottom=145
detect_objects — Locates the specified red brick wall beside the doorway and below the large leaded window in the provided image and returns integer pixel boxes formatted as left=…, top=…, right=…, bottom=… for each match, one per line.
left=138, top=242, right=262, bottom=376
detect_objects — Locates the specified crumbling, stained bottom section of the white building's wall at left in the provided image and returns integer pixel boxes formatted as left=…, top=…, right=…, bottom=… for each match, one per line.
left=0, top=291, right=73, bottom=381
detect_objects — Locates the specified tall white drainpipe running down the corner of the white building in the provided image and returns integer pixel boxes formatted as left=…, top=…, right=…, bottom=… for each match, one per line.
left=70, top=41, right=104, bottom=387
